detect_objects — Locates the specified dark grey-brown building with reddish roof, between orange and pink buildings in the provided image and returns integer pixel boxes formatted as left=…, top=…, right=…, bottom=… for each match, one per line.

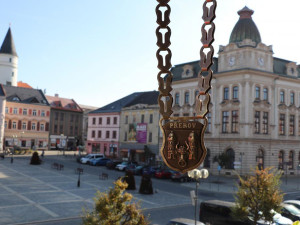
left=46, top=94, right=83, bottom=150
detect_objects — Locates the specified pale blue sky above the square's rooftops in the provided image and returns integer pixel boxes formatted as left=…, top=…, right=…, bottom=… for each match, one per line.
left=0, top=0, right=300, bottom=108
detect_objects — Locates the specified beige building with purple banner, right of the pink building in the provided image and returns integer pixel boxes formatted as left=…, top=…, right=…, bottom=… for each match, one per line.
left=120, top=91, right=160, bottom=164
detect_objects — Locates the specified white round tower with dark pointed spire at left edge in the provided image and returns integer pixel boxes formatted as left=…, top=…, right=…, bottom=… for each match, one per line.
left=0, top=27, right=18, bottom=86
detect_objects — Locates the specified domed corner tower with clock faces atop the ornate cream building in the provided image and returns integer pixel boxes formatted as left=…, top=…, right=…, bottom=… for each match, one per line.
left=218, top=6, right=273, bottom=72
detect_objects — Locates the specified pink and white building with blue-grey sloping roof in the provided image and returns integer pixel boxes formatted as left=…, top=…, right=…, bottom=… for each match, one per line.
left=86, top=92, right=140, bottom=157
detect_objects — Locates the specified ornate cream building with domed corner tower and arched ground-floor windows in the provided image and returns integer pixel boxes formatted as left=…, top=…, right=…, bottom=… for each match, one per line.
left=172, top=7, right=300, bottom=175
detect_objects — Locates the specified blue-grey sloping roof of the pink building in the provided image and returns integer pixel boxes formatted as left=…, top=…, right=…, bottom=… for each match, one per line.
left=89, top=92, right=142, bottom=114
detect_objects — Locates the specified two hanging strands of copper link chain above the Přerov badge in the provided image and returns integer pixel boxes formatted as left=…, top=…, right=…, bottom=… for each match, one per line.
left=155, top=0, right=217, bottom=120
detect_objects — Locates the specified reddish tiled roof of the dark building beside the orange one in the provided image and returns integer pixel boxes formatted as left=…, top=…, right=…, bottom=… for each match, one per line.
left=46, top=95, right=83, bottom=112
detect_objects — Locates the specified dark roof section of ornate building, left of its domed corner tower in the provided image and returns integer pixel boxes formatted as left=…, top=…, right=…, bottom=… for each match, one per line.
left=171, top=57, right=218, bottom=81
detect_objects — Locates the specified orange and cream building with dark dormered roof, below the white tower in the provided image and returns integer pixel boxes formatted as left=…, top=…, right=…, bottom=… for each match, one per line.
left=3, top=85, right=50, bottom=150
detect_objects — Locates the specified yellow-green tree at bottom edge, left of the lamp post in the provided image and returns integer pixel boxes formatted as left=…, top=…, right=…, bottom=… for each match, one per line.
left=82, top=179, right=149, bottom=225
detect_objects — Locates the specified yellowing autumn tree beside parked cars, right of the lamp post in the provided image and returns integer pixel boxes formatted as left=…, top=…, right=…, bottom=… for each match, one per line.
left=232, top=167, right=283, bottom=225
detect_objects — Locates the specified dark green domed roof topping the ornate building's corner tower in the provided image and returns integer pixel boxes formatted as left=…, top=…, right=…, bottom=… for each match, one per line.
left=229, top=6, right=261, bottom=44
